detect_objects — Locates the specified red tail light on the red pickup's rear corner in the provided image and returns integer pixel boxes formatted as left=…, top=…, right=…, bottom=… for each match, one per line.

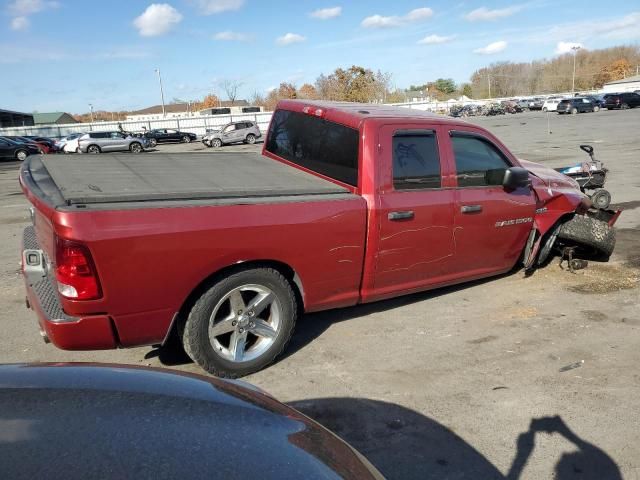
left=55, top=238, right=102, bottom=300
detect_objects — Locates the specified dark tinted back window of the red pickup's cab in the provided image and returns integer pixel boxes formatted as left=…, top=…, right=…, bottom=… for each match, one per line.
left=266, top=110, right=359, bottom=186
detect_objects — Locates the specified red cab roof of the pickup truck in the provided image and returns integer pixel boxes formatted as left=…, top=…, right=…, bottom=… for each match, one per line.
left=277, top=100, right=465, bottom=128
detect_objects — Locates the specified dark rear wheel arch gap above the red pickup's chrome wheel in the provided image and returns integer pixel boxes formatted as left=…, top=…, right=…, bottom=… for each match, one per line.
left=162, top=260, right=304, bottom=344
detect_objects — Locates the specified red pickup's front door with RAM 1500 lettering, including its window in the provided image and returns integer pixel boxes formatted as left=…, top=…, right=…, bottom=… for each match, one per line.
left=444, top=125, right=536, bottom=279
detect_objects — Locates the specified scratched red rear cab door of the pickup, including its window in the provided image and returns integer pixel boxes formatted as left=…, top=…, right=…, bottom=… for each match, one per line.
left=370, top=123, right=455, bottom=298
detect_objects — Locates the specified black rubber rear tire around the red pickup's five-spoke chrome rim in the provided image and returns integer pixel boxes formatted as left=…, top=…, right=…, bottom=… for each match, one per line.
left=182, top=268, right=297, bottom=378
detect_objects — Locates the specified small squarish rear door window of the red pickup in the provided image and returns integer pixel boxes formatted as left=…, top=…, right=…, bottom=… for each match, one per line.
left=393, top=131, right=441, bottom=190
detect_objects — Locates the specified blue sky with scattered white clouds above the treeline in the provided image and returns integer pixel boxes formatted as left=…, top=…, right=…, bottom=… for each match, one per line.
left=0, top=0, right=640, bottom=113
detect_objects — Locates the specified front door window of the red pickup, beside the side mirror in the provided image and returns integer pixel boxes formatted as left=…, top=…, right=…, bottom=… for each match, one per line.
left=451, top=133, right=511, bottom=187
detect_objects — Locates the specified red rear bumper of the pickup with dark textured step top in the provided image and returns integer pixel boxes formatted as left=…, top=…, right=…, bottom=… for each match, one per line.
left=23, top=227, right=118, bottom=350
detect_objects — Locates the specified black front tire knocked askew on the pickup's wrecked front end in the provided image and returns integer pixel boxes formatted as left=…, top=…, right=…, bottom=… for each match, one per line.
left=558, top=215, right=616, bottom=260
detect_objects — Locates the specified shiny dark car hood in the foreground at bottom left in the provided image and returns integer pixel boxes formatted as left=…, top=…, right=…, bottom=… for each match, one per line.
left=0, top=364, right=381, bottom=480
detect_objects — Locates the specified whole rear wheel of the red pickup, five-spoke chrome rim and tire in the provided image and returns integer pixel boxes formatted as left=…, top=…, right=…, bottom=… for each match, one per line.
left=182, top=268, right=297, bottom=378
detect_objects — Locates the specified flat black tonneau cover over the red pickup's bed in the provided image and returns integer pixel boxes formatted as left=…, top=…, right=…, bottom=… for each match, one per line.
left=42, top=153, right=348, bottom=205
